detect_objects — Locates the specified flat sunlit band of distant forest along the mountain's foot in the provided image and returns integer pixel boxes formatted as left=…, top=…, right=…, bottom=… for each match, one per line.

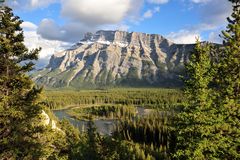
left=44, top=89, right=184, bottom=109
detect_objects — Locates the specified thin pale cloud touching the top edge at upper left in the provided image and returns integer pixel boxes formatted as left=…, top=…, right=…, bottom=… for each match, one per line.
left=7, top=0, right=59, bottom=10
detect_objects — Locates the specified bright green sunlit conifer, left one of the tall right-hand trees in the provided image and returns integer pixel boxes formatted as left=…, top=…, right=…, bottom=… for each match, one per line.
left=175, top=41, right=217, bottom=159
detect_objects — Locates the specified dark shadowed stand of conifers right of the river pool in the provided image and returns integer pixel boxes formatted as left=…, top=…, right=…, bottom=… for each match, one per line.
left=116, top=111, right=173, bottom=148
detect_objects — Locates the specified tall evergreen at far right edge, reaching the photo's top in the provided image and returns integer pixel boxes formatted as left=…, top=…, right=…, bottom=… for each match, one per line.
left=218, top=0, right=240, bottom=104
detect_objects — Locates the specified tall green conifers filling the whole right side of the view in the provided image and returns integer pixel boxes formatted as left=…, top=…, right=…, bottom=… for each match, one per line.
left=174, top=0, right=240, bottom=159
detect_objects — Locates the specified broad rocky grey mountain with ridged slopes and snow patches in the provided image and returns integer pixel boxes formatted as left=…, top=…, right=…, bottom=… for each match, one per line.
left=32, top=30, right=194, bottom=88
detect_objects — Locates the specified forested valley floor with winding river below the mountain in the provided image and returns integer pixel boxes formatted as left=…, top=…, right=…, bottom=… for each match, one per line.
left=44, top=88, right=184, bottom=160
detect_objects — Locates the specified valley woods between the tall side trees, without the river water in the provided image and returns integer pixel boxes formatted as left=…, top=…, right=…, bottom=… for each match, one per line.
left=45, top=88, right=180, bottom=160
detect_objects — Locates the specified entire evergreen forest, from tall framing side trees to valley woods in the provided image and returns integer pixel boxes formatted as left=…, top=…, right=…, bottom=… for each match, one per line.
left=0, top=0, right=240, bottom=160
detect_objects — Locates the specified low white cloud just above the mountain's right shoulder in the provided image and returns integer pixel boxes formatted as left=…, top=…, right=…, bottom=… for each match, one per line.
left=167, top=30, right=201, bottom=44
